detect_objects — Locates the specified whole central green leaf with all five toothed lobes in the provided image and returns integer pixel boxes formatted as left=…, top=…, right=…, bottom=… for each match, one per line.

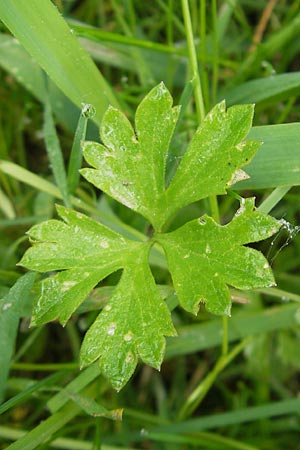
left=20, top=83, right=281, bottom=390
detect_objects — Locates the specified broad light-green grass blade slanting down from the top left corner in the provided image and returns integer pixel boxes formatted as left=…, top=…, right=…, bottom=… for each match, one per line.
left=0, top=0, right=119, bottom=122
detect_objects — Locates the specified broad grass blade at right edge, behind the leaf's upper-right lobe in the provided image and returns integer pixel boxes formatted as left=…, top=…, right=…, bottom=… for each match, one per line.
left=234, top=123, right=300, bottom=189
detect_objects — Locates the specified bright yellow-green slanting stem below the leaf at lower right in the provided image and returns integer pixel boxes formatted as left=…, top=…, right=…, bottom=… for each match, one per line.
left=178, top=336, right=252, bottom=420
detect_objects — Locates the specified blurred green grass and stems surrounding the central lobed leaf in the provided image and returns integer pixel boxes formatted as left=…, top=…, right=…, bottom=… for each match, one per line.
left=0, top=0, right=300, bottom=450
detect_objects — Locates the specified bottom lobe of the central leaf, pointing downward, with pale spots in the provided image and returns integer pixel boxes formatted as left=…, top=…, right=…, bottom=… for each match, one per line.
left=81, top=246, right=176, bottom=390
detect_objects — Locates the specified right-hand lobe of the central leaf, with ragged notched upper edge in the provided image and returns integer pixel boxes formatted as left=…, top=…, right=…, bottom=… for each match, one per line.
left=157, top=199, right=281, bottom=315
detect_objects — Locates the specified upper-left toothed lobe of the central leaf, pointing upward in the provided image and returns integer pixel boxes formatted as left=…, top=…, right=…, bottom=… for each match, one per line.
left=81, top=83, right=179, bottom=230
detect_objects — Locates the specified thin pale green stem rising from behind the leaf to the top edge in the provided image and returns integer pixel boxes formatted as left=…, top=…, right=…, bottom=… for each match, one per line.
left=181, top=0, right=205, bottom=123
